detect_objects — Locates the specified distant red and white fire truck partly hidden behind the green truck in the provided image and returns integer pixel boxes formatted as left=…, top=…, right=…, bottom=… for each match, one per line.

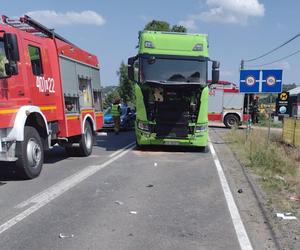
left=208, top=81, right=249, bottom=128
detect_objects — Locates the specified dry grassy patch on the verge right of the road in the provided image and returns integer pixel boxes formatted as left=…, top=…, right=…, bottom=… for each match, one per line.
left=226, top=129, right=299, bottom=197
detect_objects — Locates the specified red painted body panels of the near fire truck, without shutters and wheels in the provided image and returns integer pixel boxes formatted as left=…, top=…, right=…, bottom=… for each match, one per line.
left=0, top=17, right=103, bottom=137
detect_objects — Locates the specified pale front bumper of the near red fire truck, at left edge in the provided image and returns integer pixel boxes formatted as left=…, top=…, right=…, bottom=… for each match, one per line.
left=0, top=129, right=17, bottom=161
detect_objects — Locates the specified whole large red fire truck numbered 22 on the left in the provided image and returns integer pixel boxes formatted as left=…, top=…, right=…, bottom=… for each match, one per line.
left=0, top=16, right=103, bottom=179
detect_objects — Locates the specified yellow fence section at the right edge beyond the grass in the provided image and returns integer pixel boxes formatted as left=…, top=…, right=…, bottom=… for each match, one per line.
left=282, top=118, right=300, bottom=147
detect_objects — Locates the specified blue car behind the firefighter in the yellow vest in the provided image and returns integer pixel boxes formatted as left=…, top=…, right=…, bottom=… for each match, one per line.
left=103, top=106, right=135, bottom=130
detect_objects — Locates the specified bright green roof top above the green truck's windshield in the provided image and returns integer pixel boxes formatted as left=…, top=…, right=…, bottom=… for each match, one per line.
left=139, top=31, right=208, bottom=57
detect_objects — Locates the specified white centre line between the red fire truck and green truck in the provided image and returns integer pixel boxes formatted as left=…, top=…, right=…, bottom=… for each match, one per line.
left=0, top=143, right=133, bottom=234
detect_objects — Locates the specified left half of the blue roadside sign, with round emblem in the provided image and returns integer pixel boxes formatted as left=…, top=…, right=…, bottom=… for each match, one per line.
left=240, top=70, right=260, bottom=93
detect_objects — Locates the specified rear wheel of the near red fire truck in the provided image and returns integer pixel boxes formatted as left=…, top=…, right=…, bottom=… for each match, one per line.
left=78, top=122, right=94, bottom=156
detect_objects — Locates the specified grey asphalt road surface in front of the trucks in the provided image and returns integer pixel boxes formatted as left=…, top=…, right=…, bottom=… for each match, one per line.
left=0, top=132, right=272, bottom=250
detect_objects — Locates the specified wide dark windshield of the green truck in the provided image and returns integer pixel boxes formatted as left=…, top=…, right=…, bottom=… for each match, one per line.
left=141, top=57, right=207, bottom=85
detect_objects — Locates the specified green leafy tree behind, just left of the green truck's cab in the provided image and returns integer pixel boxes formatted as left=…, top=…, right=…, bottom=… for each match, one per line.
left=117, top=61, right=135, bottom=104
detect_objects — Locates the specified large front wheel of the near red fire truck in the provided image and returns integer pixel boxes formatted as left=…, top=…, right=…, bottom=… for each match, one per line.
left=16, top=126, right=44, bottom=179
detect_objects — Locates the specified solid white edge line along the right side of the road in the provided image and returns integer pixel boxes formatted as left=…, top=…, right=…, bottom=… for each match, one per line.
left=208, top=142, right=253, bottom=250
